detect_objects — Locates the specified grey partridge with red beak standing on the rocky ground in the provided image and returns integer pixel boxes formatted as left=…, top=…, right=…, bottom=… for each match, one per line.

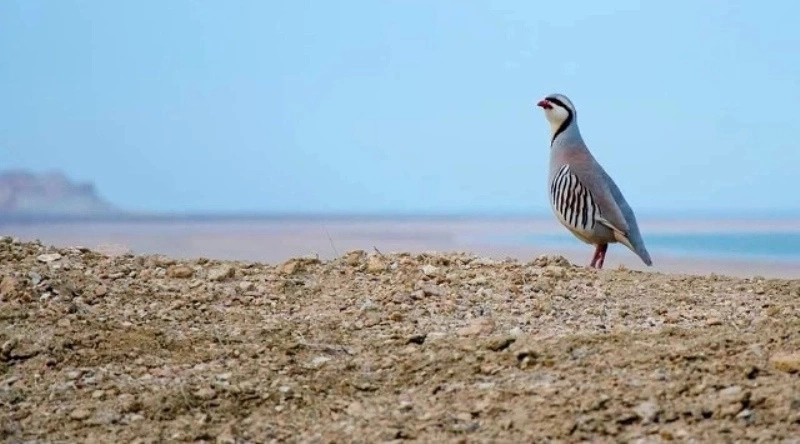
left=536, top=93, right=653, bottom=269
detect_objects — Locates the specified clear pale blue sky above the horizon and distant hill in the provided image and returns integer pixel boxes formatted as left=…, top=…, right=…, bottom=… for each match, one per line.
left=0, top=0, right=800, bottom=214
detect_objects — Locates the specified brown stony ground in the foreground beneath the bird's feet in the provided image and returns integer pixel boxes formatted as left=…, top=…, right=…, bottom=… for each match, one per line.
left=0, top=238, right=800, bottom=443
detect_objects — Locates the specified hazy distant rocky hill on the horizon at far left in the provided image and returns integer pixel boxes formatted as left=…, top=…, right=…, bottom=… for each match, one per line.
left=0, top=170, right=122, bottom=220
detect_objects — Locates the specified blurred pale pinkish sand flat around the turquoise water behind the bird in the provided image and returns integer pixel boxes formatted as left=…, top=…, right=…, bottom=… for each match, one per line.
left=0, top=217, right=800, bottom=278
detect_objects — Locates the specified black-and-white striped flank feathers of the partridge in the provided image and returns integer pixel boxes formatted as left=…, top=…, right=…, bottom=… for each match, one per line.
left=550, top=165, right=600, bottom=231
